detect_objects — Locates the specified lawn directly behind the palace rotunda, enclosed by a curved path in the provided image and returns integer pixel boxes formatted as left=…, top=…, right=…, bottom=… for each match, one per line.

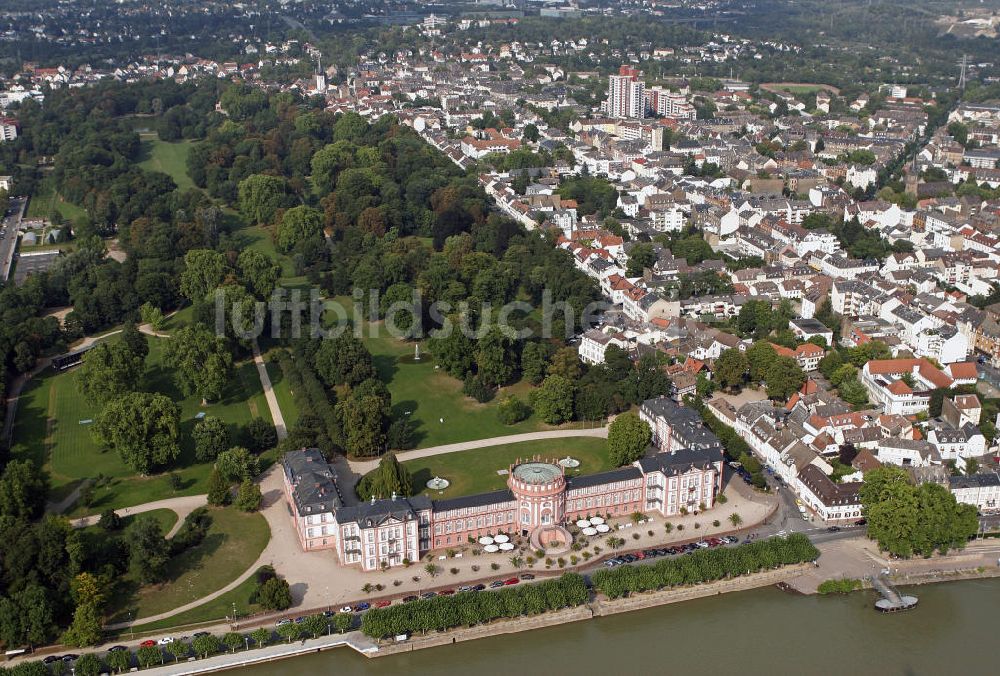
left=403, top=437, right=613, bottom=499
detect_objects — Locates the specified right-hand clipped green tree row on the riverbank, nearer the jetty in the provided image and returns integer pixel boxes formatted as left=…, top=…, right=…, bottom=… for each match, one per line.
left=592, top=533, right=819, bottom=599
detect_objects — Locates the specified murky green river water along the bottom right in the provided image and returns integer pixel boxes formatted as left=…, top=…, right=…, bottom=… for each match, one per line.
left=240, top=579, right=1000, bottom=676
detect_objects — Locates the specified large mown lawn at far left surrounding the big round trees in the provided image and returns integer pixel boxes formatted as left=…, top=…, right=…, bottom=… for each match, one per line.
left=14, top=338, right=271, bottom=516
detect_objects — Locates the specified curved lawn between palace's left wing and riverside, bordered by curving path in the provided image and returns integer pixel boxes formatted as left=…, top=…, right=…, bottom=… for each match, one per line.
left=111, top=507, right=271, bottom=622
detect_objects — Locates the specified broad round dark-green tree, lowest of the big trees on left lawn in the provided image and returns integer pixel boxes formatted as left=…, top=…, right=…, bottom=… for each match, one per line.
left=92, top=392, right=180, bottom=474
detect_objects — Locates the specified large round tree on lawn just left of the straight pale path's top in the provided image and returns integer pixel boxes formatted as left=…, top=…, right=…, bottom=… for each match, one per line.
left=164, top=324, right=233, bottom=400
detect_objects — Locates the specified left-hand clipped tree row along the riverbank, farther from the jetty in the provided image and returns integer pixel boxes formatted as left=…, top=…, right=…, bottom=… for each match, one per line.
left=361, top=573, right=589, bottom=638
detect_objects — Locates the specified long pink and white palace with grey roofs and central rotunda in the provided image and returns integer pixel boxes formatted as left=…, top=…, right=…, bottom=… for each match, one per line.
left=282, top=420, right=723, bottom=570
